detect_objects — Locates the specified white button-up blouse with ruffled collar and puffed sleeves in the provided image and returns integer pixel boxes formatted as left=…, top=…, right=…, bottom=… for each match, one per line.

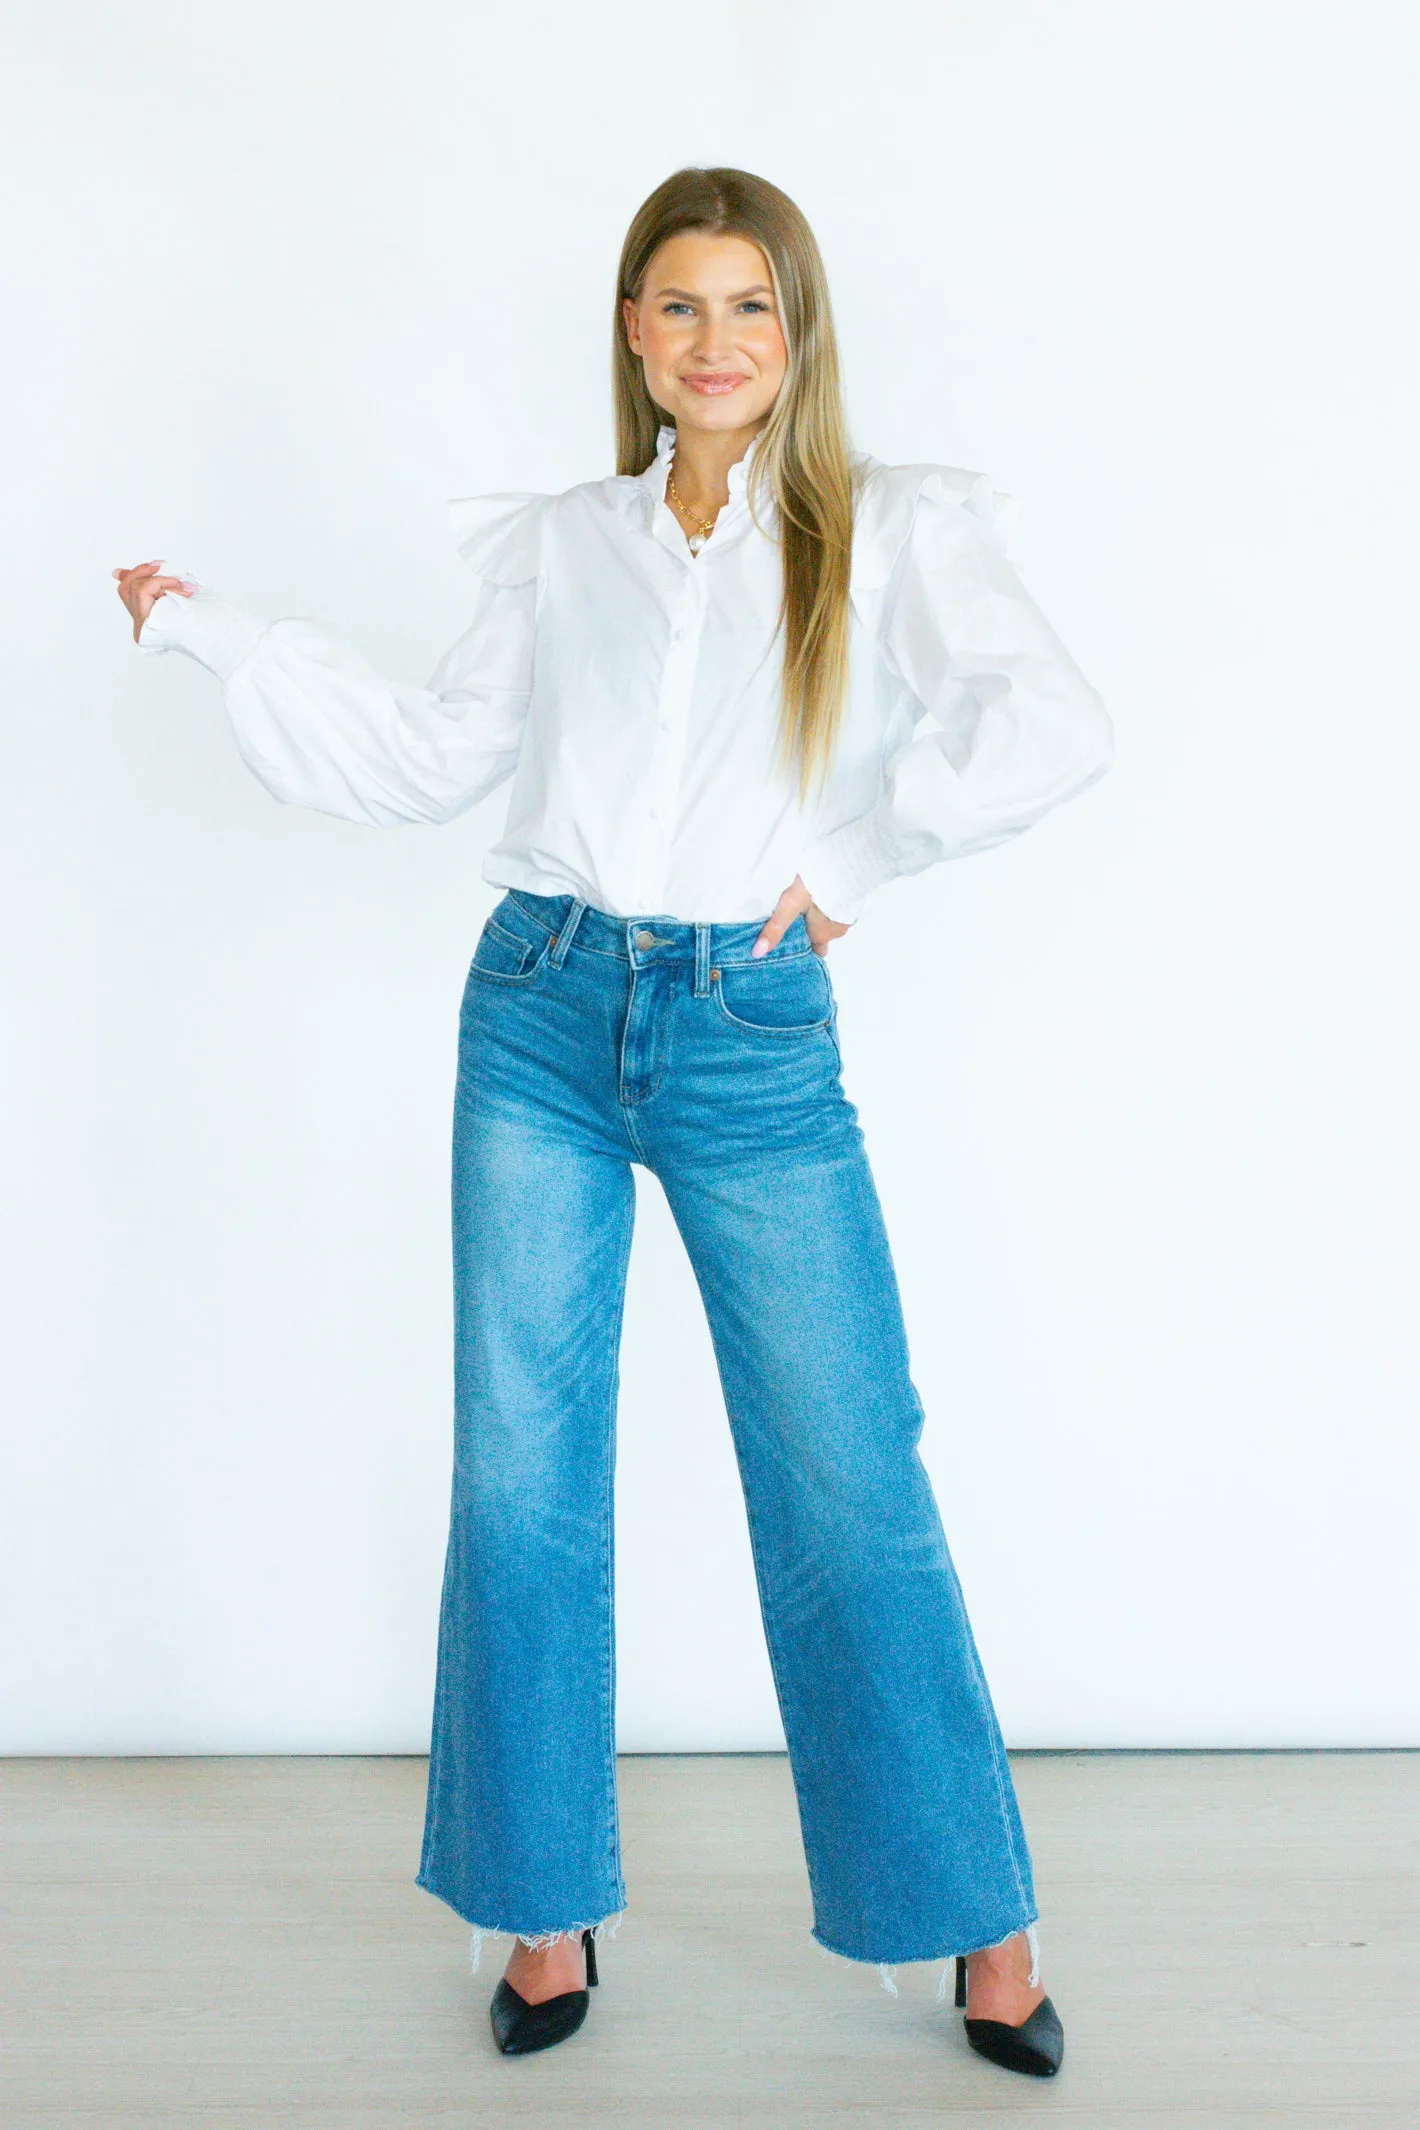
left=138, top=428, right=1113, bottom=922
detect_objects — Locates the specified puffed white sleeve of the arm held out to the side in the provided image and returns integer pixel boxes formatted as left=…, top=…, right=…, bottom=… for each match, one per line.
left=138, top=494, right=549, bottom=829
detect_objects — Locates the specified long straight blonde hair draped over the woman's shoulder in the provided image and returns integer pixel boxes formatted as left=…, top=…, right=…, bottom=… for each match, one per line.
left=611, top=168, right=854, bottom=801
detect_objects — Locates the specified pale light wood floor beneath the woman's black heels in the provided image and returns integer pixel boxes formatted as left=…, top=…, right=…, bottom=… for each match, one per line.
left=0, top=1753, right=1420, bottom=2130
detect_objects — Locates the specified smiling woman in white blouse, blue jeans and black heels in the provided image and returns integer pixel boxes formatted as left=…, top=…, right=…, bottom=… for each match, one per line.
left=115, top=170, right=1111, bottom=2075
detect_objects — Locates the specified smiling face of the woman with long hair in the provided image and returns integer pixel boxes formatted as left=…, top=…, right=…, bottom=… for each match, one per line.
left=622, top=230, right=788, bottom=432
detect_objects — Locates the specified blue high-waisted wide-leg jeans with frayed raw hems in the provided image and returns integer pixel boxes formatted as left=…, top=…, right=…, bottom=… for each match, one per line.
left=419, top=890, right=1037, bottom=1964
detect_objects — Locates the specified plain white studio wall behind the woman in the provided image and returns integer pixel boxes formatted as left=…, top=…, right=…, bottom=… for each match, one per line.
left=0, top=0, right=1420, bottom=1753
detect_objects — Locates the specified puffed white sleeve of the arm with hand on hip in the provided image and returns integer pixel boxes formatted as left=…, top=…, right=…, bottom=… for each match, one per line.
left=798, top=466, right=1113, bottom=924
